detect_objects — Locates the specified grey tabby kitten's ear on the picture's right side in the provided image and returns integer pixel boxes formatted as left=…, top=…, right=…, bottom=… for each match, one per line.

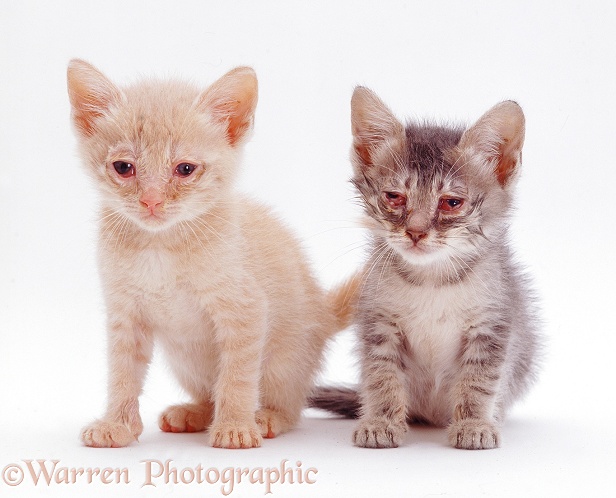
left=458, top=100, right=524, bottom=186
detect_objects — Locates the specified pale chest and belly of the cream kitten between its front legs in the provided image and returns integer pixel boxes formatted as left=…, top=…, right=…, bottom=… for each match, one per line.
left=101, top=243, right=220, bottom=399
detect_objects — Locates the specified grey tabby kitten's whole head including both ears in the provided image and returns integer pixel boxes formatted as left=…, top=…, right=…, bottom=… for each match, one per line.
left=352, top=88, right=523, bottom=272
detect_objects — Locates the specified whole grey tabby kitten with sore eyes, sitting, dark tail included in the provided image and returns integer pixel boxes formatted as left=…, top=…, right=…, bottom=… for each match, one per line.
left=311, top=87, right=540, bottom=449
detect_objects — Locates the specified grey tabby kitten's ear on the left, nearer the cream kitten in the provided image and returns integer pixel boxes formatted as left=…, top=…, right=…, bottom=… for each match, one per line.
left=351, top=86, right=404, bottom=167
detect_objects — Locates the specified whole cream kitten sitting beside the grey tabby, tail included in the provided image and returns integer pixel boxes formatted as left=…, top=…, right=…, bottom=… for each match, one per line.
left=68, top=60, right=355, bottom=448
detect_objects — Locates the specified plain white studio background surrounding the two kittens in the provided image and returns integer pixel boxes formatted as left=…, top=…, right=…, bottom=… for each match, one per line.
left=0, top=0, right=616, bottom=497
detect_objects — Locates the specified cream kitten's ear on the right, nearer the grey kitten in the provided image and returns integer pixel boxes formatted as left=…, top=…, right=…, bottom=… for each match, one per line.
left=197, top=67, right=258, bottom=146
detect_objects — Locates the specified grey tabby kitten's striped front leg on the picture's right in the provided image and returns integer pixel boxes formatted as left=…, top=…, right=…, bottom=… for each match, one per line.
left=448, top=329, right=507, bottom=450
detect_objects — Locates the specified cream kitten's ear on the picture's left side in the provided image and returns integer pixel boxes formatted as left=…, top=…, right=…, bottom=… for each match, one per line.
left=67, top=59, right=121, bottom=136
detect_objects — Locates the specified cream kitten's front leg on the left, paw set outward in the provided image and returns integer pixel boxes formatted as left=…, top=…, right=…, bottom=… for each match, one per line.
left=81, top=322, right=153, bottom=448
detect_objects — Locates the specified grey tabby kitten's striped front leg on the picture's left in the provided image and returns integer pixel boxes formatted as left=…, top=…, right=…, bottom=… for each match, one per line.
left=353, top=317, right=407, bottom=448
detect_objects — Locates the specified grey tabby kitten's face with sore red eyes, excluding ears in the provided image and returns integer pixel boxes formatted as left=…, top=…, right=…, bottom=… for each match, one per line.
left=355, top=122, right=482, bottom=265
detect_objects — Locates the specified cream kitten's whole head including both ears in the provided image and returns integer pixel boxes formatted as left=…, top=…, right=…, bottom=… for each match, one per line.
left=69, top=61, right=257, bottom=232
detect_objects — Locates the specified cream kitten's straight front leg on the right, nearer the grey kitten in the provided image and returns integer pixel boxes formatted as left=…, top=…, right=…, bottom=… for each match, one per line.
left=210, top=286, right=267, bottom=448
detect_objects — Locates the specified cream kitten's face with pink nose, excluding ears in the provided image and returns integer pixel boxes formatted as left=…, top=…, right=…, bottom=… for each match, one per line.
left=96, top=84, right=230, bottom=231
